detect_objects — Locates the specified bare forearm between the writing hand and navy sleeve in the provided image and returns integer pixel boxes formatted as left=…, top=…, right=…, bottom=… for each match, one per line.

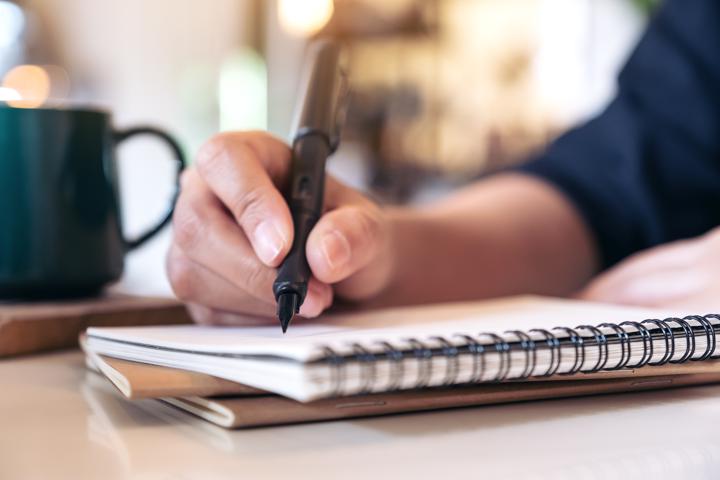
left=373, top=174, right=598, bottom=305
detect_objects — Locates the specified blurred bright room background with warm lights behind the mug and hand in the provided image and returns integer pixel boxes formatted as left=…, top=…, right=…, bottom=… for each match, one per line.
left=0, top=0, right=657, bottom=293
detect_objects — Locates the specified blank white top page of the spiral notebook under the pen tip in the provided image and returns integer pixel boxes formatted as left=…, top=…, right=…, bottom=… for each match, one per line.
left=88, top=296, right=671, bottom=361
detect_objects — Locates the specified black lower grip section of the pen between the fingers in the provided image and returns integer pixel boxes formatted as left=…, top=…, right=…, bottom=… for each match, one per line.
left=273, top=133, right=331, bottom=305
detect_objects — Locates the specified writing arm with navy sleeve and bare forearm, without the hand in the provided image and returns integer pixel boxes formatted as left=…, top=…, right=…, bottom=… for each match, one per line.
left=366, top=0, right=720, bottom=303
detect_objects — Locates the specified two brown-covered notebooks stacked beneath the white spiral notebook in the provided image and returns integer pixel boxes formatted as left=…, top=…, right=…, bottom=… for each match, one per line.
left=86, top=344, right=720, bottom=428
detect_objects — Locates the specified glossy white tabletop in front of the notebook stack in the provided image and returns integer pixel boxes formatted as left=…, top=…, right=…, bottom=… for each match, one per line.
left=0, top=352, right=720, bottom=480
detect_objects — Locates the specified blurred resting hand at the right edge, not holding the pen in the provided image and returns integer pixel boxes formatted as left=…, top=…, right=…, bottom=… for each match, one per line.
left=580, top=228, right=720, bottom=314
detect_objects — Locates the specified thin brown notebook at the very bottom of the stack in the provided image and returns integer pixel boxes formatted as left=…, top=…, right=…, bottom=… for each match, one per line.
left=162, top=373, right=720, bottom=428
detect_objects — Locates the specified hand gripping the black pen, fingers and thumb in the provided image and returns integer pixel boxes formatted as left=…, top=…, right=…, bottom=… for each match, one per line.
left=167, top=132, right=393, bottom=324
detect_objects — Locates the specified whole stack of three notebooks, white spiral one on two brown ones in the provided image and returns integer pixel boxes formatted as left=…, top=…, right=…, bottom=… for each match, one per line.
left=82, top=297, right=720, bottom=428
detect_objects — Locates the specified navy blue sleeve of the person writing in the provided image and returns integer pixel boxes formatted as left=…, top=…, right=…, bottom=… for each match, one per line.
left=520, top=0, right=720, bottom=267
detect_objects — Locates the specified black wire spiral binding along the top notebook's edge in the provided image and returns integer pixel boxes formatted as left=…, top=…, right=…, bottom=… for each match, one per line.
left=323, top=314, right=720, bottom=395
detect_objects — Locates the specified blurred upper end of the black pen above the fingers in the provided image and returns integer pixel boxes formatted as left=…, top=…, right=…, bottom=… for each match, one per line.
left=293, top=40, right=347, bottom=148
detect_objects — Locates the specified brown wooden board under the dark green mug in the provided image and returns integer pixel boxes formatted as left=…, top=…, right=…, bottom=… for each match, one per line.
left=0, top=294, right=191, bottom=358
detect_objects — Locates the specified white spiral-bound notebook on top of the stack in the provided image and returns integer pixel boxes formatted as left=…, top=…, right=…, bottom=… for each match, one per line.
left=87, top=297, right=720, bottom=402
